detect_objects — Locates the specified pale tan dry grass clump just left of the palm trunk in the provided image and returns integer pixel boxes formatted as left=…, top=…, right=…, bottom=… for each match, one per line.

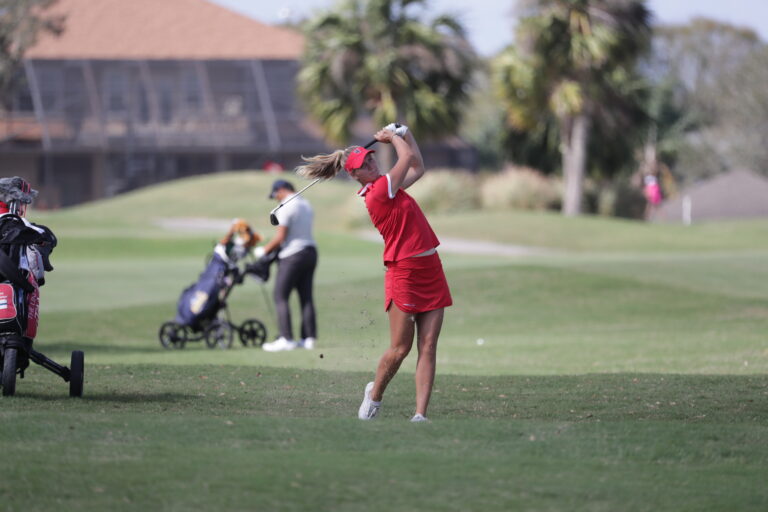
left=480, top=167, right=563, bottom=210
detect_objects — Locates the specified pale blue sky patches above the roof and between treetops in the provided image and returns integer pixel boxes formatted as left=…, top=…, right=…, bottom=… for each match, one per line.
left=211, top=0, right=768, bottom=55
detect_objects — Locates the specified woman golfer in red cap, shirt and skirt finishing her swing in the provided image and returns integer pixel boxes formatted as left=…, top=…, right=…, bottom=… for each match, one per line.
left=299, top=125, right=452, bottom=422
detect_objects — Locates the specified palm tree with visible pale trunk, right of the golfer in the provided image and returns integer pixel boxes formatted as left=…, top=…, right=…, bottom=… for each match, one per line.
left=495, top=0, right=651, bottom=216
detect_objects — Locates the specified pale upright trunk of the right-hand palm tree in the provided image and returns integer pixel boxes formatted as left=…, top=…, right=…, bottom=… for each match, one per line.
left=561, top=112, right=591, bottom=217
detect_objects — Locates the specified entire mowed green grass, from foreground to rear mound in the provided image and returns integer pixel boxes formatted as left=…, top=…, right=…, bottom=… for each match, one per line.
left=0, top=173, right=768, bottom=511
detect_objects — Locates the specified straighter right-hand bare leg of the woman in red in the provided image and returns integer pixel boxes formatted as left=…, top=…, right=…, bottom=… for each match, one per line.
left=416, top=308, right=445, bottom=416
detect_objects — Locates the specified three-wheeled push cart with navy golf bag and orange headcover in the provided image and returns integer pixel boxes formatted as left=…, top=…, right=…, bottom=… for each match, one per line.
left=158, top=219, right=276, bottom=349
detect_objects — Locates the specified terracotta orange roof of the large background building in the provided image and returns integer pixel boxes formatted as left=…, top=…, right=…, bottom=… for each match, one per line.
left=27, top=0, right=304, bottom=59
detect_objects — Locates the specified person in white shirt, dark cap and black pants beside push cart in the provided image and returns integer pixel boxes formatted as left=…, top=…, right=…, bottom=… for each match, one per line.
left=262, top=180, right=317, bottom=352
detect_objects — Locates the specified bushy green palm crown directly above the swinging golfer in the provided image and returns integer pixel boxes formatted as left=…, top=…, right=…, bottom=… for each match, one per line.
left=298, top=0, right=476, bottom=142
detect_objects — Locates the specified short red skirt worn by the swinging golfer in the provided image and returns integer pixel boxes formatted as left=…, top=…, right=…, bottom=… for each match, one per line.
left=384, top=253, right=453, bottom=314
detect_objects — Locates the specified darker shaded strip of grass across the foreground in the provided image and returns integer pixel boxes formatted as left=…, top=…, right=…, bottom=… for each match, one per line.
left=0, top=365, right=768, bottom=511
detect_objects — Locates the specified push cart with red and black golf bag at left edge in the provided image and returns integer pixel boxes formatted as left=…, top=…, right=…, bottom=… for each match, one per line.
left=0, top=177, right=85, bottom=397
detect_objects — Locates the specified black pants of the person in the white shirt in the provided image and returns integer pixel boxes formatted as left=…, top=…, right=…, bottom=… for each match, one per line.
left=274, top=247, right=317, bottom=340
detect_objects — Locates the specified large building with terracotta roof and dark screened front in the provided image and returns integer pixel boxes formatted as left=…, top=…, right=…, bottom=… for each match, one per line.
left=0, top=0, right=328, bottom=207
